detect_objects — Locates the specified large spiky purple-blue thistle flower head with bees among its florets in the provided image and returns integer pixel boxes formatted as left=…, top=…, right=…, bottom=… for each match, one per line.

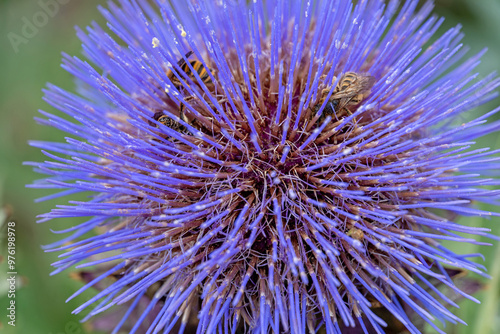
left=31, top=0, right=500, bottom=334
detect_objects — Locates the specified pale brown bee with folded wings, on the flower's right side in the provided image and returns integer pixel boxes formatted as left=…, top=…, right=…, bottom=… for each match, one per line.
left=313, top=72, right=375, bottom=121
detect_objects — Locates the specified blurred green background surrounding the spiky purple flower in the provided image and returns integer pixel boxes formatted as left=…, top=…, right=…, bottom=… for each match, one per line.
left=0, top=0, right=500, bottom=334
